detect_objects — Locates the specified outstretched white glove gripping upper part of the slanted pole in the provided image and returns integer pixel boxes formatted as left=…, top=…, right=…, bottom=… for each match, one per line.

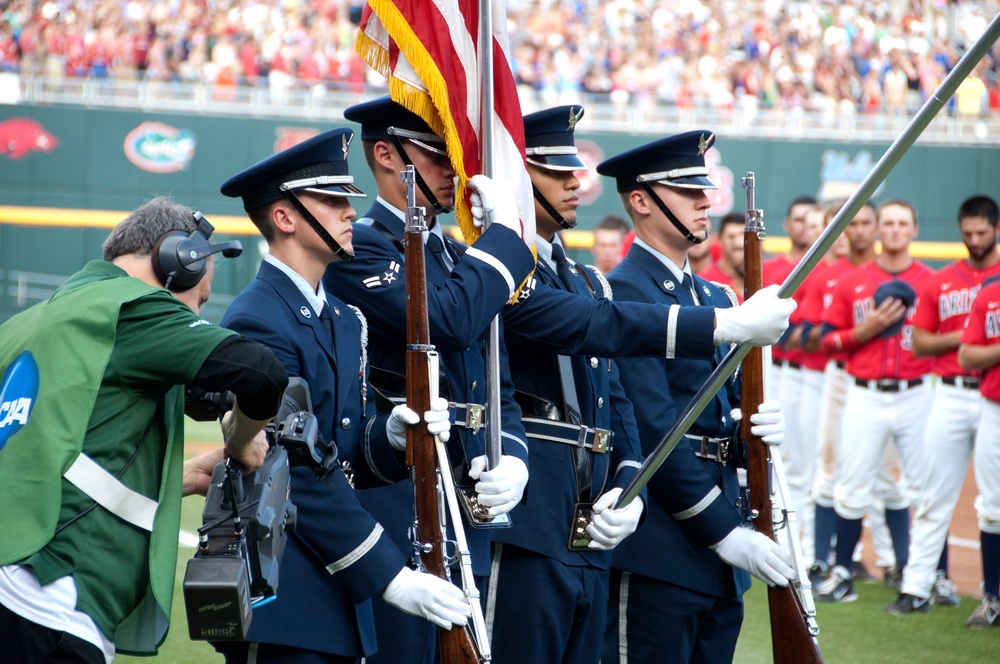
left=713, top=284, right=798, bottom=346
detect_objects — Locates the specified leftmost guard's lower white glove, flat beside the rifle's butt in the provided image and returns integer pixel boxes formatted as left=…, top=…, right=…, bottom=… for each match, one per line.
left=382, top=567, right=472, bottom=629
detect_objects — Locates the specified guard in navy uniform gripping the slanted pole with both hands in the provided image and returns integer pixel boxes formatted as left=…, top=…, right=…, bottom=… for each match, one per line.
left=487, top=106, right=787, bottom=664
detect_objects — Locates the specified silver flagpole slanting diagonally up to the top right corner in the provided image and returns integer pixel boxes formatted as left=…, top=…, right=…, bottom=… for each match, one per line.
left=615, top=13, right=1000, bottom=508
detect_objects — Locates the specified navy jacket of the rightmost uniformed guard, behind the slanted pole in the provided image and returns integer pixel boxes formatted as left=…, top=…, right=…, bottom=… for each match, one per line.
left=608, top=245, right=750, bottom=597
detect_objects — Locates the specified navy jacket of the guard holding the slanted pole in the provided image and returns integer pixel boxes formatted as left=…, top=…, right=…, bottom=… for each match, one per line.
left=495, top=252, right=648, bottom=568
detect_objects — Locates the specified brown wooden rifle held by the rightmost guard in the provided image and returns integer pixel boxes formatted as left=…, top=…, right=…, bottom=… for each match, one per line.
left=740, top=172, right=823, bottom=664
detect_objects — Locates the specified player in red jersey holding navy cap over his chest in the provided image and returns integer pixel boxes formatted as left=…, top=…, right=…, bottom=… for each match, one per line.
left=817, top=199, right=933, bottom=602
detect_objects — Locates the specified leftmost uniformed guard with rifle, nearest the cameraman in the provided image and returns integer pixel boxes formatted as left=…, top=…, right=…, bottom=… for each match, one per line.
left=215, top=129, right=469, bottom=664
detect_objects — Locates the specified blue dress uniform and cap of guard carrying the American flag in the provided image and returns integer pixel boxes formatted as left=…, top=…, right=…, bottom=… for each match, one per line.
left=324, top=97, right=534, bottom=664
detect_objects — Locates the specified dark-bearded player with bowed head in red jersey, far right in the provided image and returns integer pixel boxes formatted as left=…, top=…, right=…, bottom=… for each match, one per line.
left=885, top=196, right=1000, bottom=614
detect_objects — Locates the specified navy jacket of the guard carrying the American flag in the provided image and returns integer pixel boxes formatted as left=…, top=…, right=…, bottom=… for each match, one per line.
left=323, top=202, right=534, bottom=576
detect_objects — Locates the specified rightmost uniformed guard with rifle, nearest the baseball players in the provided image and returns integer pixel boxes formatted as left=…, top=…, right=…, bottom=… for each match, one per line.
left=597, top=131, right=795, bottom=664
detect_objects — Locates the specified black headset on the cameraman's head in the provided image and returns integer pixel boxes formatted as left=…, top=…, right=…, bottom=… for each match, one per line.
left=153, top=212, right=243, bottom=293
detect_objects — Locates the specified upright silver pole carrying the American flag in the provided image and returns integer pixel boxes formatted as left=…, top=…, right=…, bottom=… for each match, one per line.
left=479, top=0, right=502, bottom=468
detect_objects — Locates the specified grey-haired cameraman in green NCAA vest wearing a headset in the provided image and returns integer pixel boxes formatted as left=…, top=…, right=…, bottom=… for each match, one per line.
left=0, top=198, right=288, bottom=664
